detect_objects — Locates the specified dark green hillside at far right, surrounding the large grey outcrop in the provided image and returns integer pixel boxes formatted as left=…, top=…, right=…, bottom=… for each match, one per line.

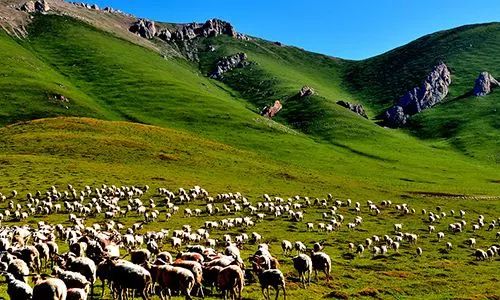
left=344, top=23, right=500, bottom=164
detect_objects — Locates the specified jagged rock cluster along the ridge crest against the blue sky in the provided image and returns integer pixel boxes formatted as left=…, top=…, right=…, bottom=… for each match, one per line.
left=130, top=19, right=248, bottom=42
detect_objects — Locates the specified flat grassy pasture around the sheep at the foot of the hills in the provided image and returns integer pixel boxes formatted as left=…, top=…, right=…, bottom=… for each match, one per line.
left=0, top=186, right=500, bottom=299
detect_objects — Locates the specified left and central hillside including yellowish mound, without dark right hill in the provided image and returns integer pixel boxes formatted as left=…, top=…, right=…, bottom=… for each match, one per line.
left=0, top=15, right=500, bottom=197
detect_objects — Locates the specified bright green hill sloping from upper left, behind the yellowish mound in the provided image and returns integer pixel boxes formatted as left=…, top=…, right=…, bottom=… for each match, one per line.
left=2, top=16, right=492, bottom=196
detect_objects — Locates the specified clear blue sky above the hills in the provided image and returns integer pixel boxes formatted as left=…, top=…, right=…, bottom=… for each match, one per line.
left=89, top=0, right=500, bottom=59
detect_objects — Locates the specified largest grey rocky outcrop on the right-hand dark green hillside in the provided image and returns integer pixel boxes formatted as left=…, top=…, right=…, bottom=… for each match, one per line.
left=384, top=63, right=451, bottom=127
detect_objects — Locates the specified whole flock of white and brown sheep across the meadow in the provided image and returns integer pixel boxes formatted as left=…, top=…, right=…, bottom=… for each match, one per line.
left=0, top=185, right=500, bottom=300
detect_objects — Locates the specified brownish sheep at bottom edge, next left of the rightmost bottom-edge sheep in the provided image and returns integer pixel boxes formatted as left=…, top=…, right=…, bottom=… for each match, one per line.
left=217, top=265, right=245, bottom=300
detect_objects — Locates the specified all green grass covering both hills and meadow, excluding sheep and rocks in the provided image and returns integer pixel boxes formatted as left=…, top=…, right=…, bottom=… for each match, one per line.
left=0, top=15, right=500, bottom=299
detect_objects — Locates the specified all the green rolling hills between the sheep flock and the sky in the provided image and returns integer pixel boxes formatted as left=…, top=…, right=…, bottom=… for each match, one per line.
left=0, top=3, right=500, bottom=197
